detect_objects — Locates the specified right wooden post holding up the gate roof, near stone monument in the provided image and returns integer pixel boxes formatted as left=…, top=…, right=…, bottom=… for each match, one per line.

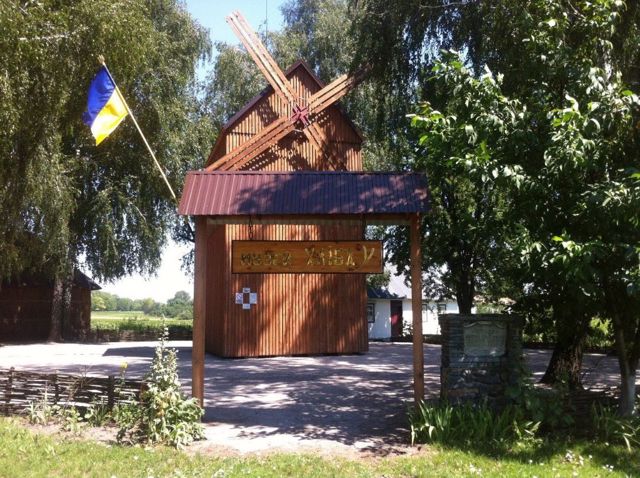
left=409, top=214, right=424, bottom=405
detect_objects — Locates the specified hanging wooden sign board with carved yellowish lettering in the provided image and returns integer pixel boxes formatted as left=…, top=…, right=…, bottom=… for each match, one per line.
left=231, top=241, right=382, bottom=274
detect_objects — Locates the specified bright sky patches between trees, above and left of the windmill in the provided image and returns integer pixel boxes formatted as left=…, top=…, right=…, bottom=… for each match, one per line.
left=101, top=0, right=285, bottom=302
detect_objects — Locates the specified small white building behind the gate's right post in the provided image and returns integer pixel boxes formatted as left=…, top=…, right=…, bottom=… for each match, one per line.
left=367, top=275, right=458, bottom=340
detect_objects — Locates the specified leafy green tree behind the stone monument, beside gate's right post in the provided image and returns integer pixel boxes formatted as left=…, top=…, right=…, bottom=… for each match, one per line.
left=387, top=53, right=526, bottom=314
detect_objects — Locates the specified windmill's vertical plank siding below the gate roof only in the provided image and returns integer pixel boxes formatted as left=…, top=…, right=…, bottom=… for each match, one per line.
left=207, top=224, right=368, bottom=357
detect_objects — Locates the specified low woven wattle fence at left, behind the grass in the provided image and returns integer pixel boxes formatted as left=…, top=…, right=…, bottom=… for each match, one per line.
left=0, top=368, right=145, bottom=415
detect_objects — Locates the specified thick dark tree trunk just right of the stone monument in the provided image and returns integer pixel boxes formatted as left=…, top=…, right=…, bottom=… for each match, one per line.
left=540, top=310, right=589, bottom=389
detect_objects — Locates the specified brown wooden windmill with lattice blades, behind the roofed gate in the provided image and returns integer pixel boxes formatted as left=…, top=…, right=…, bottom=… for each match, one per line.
left=190, top=14, right=368, bottom=357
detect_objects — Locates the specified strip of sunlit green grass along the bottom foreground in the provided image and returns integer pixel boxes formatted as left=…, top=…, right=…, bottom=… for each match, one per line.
left=0, top=418, right=640, bottom=478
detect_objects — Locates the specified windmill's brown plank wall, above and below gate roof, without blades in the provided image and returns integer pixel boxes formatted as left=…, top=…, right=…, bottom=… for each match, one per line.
left=206, top=64, right=368, bottom=357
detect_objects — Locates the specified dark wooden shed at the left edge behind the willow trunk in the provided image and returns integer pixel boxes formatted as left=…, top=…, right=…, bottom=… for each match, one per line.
left=0, top=269, right=100, bottom=342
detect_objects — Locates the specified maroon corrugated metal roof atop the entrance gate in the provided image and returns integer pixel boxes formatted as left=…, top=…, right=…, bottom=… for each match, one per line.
left=178, top=171, right=428, bottom=216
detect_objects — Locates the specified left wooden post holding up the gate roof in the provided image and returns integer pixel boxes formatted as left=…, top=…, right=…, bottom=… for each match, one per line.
left=191, top=216, right=208, bottom=407
